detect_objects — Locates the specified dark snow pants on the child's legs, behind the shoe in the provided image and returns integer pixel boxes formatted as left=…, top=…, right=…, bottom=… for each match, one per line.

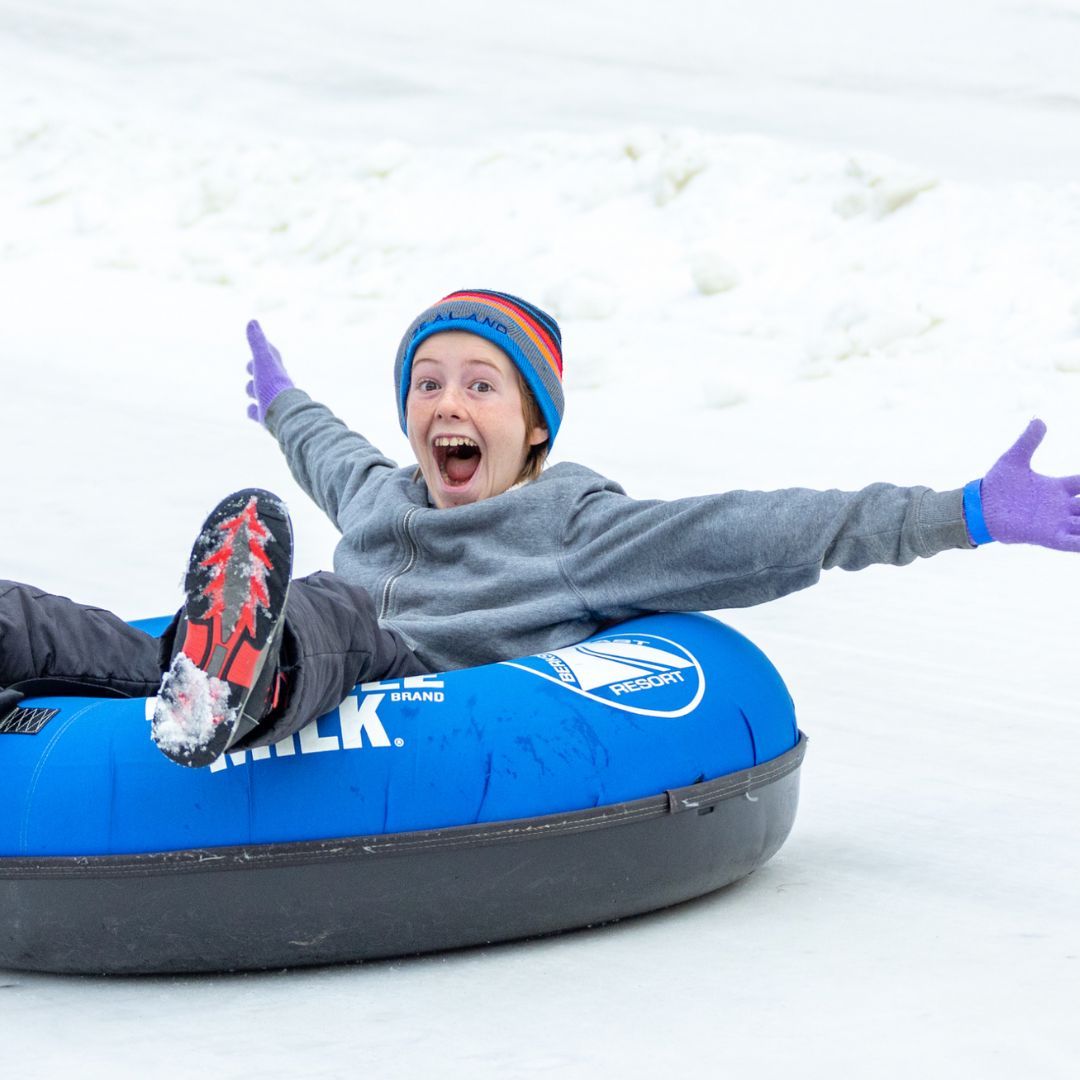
left=0, top=572, right=429, bottom=748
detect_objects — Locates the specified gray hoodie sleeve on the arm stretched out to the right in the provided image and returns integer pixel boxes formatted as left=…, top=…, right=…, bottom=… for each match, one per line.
left=562, top=484, right=972, bottom=619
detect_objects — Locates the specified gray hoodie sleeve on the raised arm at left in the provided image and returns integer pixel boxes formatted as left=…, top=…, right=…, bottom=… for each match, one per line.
left=266, top=390, right=397, bottom=529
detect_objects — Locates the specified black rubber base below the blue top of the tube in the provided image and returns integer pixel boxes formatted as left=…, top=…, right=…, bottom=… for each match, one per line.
left=0, top=737, right=806, bottom=974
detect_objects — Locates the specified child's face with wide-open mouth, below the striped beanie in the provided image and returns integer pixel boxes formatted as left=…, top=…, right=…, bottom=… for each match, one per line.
left=405, top=330, right=548, bottom=510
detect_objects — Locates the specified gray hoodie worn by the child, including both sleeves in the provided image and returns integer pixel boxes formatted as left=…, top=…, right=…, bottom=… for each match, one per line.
left=267, top=390, right=973, bottom=671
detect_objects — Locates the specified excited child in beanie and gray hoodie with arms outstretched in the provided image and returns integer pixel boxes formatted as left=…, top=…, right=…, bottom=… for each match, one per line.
left=0, top=289, right=1080, bottom=765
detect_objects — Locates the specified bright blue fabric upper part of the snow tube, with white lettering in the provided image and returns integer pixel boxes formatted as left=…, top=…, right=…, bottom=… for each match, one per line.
left=0, top=615, right=798, bottom=855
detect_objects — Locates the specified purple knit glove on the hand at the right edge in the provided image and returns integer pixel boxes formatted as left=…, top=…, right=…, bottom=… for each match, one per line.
left=964, top=412, right=1080, bottom=552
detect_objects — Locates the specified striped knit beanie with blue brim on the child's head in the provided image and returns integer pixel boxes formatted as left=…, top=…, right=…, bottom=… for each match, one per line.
left=394, top=288, right=564, bottom=448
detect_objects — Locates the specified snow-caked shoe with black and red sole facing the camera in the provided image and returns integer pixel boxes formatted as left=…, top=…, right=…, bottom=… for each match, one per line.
left=151, top=488, right=293, bottom=768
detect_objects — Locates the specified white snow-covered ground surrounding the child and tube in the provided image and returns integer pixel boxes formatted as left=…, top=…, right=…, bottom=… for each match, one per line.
left=0, top=0, right=1080, bottom=1078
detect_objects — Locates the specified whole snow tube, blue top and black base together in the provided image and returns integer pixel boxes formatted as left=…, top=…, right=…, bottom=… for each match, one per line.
left=0, top=615, right=805, bottom=972
